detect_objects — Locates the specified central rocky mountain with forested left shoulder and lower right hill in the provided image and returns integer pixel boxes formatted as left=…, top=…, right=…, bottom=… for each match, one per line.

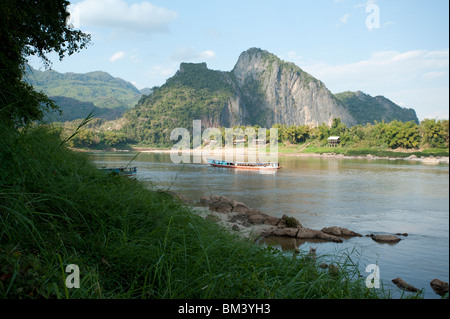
left=124, top=48, right=418, bottom=142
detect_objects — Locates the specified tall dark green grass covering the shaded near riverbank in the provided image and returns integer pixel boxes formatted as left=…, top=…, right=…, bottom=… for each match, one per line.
left=0, top=127, right=383, bottom=298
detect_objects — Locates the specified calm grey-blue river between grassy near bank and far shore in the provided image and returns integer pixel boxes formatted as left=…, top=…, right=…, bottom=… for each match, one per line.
left=91, top=152, right=449, bottom=299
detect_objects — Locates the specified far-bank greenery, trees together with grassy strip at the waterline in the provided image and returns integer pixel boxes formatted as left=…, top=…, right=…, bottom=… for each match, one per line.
left=61, top=119, right=449, bottom=157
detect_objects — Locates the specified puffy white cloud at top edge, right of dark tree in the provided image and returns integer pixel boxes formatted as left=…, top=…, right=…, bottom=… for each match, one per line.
left=69, top=0, right=178, bottom=33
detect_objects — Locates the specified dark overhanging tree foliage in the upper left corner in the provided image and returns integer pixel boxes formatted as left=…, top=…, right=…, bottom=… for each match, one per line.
left=0, top=0, right=91, bottom=126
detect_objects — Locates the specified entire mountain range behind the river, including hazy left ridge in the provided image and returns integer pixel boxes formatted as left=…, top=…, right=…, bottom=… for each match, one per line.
left=26, top=48, right=419, bottom=132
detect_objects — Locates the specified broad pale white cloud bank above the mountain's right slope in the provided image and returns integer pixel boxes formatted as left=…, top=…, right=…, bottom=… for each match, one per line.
left=288, top=49, right=449, bottom=119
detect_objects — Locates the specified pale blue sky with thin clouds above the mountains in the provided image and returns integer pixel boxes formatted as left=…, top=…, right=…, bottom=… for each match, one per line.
left=30, top=0, right=449, bottom=120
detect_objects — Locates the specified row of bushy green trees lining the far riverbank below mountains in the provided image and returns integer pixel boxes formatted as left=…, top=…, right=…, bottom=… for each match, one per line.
left=66, top=114, right=449, bottom=149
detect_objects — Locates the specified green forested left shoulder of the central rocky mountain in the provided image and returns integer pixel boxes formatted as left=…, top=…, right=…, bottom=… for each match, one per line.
left=123, top=63, right=233, bottom=144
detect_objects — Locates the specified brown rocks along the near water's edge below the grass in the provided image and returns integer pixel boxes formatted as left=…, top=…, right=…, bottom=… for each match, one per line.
left=179, top=194, right=449, bottom=298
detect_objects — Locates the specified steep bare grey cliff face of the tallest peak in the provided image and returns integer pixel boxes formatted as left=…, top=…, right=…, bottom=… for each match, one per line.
left=232, top=48, right=356, bottom=127
